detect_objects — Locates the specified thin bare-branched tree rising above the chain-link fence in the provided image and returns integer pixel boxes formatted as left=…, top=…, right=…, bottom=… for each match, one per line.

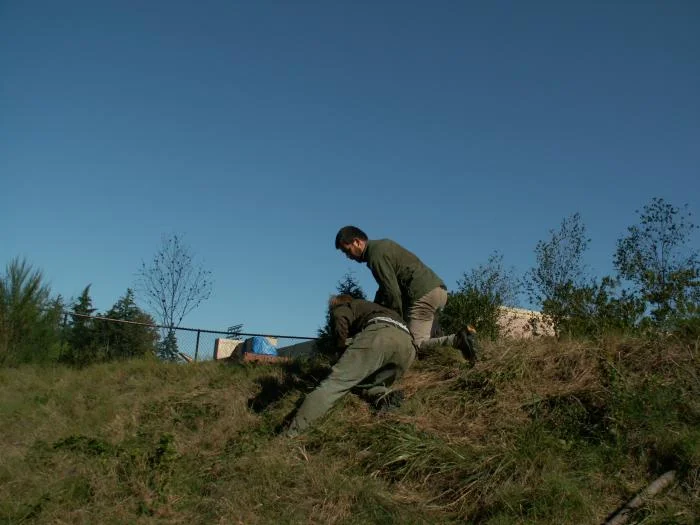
left=137, top=235, right=212, bottom=330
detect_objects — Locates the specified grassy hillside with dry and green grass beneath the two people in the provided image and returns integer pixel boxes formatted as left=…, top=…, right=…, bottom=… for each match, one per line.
left=0, top=339, right=700, bottom=524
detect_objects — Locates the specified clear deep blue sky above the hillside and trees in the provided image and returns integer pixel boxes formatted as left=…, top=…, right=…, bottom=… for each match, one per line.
left=0, top=0, right=700, bottom=335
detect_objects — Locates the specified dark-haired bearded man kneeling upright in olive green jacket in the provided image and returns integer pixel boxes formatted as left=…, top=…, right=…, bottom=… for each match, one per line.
left=335, top=226, right=477, bottom=363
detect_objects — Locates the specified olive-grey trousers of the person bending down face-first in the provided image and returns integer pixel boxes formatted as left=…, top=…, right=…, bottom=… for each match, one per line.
left=288, top=323, right=416, bottom=436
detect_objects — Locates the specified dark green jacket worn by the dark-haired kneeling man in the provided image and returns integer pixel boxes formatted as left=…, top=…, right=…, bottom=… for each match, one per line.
left=362, top=239, right=445, bottom=317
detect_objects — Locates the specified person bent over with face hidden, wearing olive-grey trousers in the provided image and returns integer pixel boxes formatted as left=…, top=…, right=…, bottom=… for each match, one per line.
left=287, top=295, right=416, bottom=437
